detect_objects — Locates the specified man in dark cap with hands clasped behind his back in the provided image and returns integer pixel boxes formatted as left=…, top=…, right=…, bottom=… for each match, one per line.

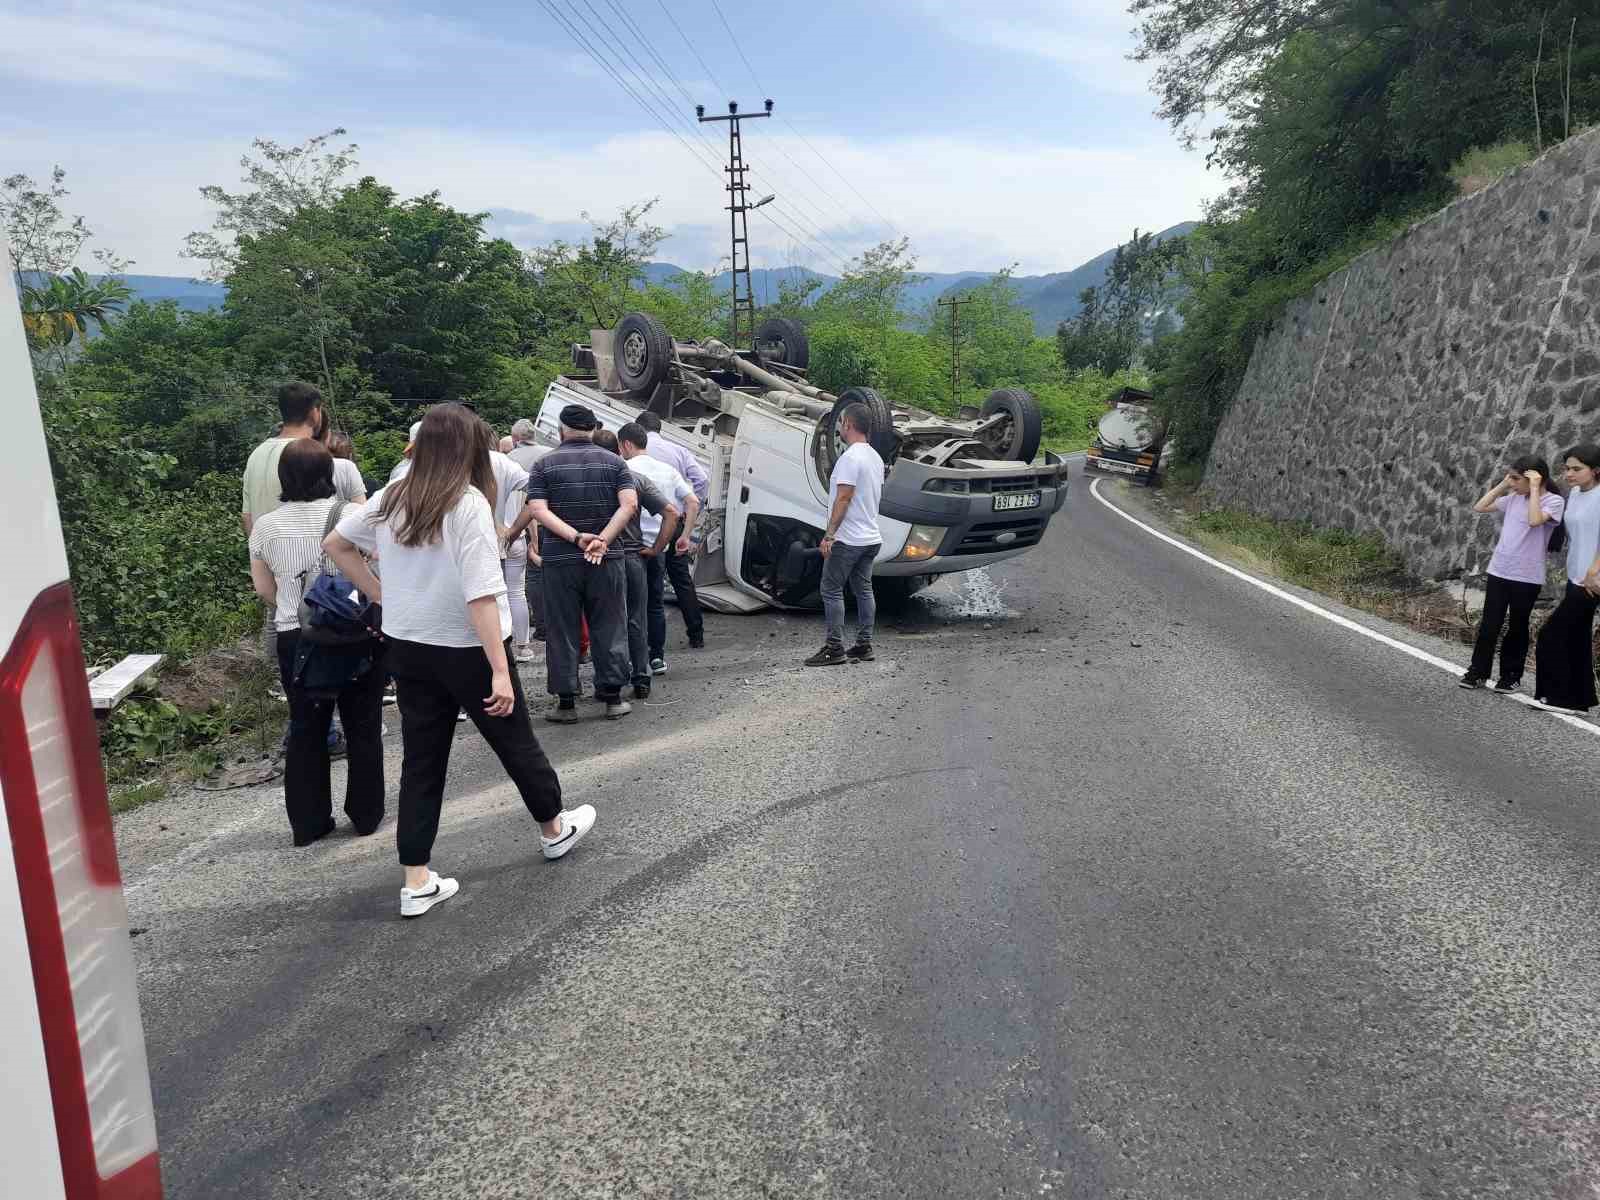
left=510, top=405, right=638, bottom=725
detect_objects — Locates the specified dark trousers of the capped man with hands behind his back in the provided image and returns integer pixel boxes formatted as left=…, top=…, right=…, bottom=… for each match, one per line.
left=544, top=557, right=629, bottom=696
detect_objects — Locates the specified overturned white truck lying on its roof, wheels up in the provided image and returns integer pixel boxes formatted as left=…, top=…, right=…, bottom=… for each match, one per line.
left=536, top=314, right=1067, bottom=611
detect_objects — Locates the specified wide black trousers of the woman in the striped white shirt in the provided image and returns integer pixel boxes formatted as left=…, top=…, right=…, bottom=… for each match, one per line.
left=278, top=629, right=386, bottom=842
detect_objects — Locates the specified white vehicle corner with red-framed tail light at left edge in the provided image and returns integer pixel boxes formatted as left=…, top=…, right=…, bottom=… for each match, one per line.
left=0, top=238, right=162, bottom=1200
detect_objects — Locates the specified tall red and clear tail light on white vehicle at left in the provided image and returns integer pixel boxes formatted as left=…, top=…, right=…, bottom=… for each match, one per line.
left=0, top=584, right=162, bottom=1200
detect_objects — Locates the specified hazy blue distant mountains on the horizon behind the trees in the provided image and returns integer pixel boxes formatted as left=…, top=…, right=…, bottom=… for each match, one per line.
left=112, top=221, right=1195, bottom=334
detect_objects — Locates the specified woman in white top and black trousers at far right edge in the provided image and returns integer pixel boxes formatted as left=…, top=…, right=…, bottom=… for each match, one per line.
left=1533, top=442, right=1600, bottom=712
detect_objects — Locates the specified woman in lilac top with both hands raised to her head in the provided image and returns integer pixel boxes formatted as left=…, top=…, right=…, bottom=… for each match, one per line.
left=1461, top=454, right=1565, bottom=691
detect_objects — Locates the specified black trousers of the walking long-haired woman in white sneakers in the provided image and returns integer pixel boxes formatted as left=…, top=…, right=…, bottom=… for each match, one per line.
left=389, top=638, right=562, bottom=867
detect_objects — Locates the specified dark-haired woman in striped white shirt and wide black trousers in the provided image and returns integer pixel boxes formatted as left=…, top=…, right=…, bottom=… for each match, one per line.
left=250, top=437, right=384, bottom=846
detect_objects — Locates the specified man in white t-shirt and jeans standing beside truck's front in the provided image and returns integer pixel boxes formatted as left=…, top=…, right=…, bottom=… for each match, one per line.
left=805, top=405, right=883, bottom=667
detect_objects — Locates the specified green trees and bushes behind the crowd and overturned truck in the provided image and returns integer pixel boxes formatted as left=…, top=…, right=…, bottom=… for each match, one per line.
left=0, top=143, right=1142, bottom=659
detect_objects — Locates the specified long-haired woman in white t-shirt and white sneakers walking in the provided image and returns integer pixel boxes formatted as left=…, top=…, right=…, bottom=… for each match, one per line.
left=325, top=403, right=595, bottom=917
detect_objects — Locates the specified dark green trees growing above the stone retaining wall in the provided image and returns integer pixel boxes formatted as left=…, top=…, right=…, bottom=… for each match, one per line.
left=1131, top=0, right=1600, bottom=462
